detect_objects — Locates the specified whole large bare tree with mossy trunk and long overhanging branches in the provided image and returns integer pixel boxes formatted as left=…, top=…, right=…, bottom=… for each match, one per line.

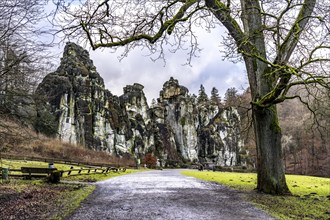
left=57, top=0, right=330, bottom=194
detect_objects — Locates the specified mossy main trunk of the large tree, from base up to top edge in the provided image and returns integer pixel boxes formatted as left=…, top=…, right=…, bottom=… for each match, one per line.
left=236, top=0, right=289, bottom=194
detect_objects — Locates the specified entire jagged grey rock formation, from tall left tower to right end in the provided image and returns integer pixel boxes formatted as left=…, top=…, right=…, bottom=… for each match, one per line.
left=36, top=43, right=241, bottom=166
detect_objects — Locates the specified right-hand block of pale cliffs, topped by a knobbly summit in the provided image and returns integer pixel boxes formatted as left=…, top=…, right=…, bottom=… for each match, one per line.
left=151, top=78, right=241, bottom=166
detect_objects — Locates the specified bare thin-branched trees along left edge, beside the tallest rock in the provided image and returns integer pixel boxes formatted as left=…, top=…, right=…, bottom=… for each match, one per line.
left=0, top=0, right=52, bottom=148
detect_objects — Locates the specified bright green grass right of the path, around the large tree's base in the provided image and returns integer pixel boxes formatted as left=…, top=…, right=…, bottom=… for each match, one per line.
left=182, top=171, right=330, bottom=219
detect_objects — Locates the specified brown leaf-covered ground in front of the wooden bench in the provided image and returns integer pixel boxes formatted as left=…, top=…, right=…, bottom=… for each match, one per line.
left=0, top=181, right=85, bottom=220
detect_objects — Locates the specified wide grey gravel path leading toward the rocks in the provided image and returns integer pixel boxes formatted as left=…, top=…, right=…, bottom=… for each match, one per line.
left=68, top=170, right=273, bottom=220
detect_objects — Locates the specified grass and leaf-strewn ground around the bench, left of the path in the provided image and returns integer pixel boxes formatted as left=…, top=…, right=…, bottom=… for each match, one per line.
left=0, top=159, right=138, bottom=219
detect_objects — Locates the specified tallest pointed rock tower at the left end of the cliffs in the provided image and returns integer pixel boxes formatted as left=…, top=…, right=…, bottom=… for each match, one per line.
left=36, top=44, right=116, bottom=152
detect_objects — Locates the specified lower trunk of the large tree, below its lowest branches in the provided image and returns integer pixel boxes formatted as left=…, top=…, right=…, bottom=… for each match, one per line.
left=253, top=105, right=290, bottom=194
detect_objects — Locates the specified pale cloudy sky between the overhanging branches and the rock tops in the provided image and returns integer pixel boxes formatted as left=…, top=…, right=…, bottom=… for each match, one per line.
left=90, top=27, right=247, bottom=103
